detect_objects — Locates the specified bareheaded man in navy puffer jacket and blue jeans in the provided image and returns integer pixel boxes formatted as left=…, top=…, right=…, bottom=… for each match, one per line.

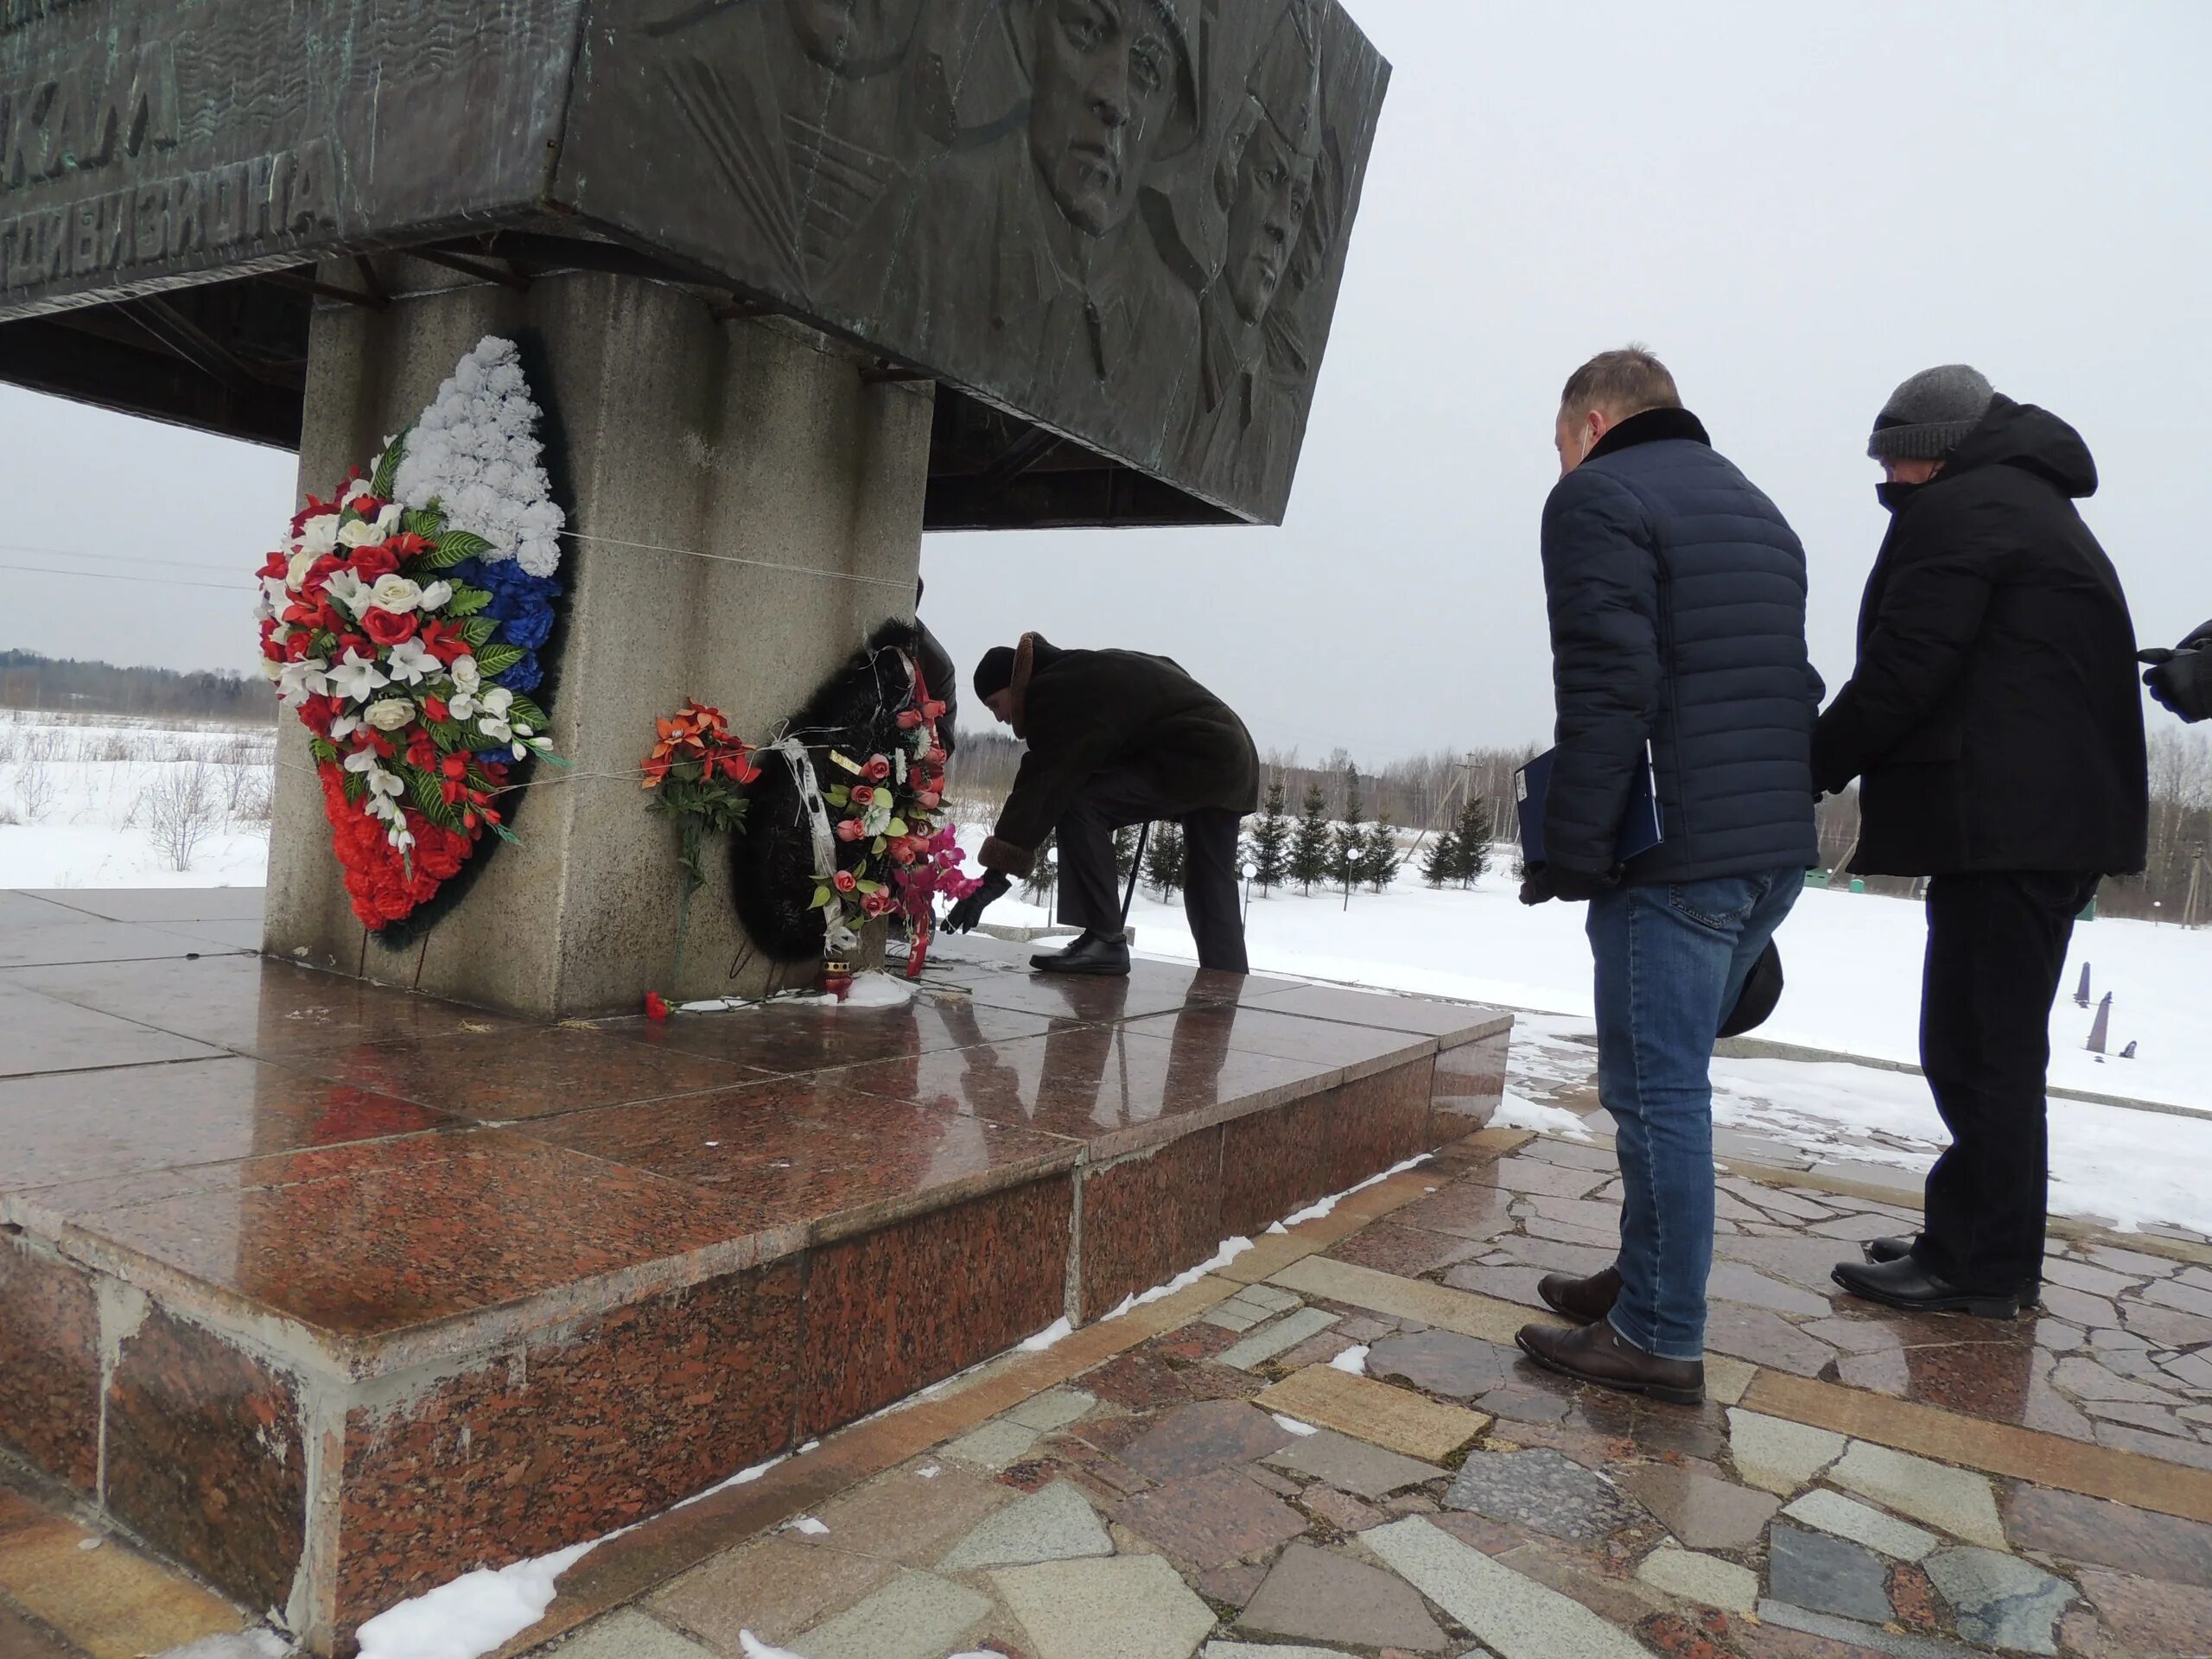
left=1520, top=347, right=1821, bottom=1405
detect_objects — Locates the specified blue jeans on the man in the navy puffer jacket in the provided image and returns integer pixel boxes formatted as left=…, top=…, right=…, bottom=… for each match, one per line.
left=1588, top=868, right=1805, bottom=1360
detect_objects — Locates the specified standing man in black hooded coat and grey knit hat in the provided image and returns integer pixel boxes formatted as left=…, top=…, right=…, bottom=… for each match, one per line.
left=1814, top=365, right=2148, bottom=1319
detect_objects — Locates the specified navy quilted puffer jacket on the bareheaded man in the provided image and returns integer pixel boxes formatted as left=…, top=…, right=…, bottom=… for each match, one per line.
left=1544, top=410, right=1821, bottom=885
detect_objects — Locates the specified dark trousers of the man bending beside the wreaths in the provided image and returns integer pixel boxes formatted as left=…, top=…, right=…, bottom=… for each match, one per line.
left=1053, top=766, right=1249, bottom=973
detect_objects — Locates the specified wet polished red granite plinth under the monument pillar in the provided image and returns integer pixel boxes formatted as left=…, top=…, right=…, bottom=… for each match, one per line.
left=0, top=889, right=1510, bottom=1648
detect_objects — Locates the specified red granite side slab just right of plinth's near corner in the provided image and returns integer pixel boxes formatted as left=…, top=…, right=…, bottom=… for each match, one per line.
left=336, top=1261, right=801, bottom=1635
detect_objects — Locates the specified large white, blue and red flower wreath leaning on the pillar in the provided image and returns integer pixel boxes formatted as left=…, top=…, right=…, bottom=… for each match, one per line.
left=257, top=339, right=564, bottom=931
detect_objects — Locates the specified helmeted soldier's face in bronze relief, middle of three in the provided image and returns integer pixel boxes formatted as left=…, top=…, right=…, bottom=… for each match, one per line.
left=1028, top=0, right=1179, bottom=237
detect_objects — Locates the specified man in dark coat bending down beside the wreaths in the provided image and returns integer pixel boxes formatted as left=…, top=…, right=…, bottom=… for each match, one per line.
left=947, top=632, right=1259, bottom=973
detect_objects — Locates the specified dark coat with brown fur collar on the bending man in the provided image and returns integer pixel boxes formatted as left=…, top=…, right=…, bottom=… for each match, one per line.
left=978, top=632, right=1259, bottom=876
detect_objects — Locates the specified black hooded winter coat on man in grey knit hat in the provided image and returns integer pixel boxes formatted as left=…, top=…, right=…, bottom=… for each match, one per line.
left=1814, top=398, right=2150, bottom=876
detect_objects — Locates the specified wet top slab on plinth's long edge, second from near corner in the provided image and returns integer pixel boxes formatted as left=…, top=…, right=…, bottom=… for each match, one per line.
left=518, top=1073, right=1082, bottom=1255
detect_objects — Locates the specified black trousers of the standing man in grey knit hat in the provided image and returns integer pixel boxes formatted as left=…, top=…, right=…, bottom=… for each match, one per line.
left=1913, top=872, right=2097, bottom=1294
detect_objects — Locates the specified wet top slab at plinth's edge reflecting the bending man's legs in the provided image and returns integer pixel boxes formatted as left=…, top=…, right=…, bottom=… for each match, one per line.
left=821, top=1022, right=1330, bottom=1159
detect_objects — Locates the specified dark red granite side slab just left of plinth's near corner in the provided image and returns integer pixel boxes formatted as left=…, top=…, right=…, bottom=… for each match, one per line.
left=104, top=1307, right=308, bottom=1608
